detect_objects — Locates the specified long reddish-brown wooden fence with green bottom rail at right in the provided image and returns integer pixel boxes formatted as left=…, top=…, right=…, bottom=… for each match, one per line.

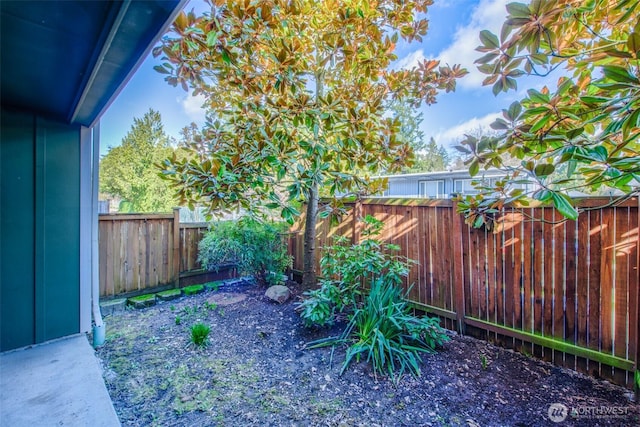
left=289, top=198, right=640, bottom=387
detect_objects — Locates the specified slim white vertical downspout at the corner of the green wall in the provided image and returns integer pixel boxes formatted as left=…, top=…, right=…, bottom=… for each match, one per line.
left=91, top=121, right=106, bottom=347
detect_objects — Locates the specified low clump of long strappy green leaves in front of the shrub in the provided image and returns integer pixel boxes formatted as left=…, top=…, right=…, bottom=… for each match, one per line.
left=310, top=279, right=449, bottom=380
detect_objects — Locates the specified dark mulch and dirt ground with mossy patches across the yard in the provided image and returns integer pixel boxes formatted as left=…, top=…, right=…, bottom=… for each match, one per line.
left=97, top=283, right=640, bottom=427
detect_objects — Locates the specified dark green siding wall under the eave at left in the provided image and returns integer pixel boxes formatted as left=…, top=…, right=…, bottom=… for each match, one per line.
left=0, top=109, right=80, bottom=351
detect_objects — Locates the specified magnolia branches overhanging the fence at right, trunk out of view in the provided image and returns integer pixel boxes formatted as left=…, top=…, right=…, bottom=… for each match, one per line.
left=460, top=0, right=640, bottom=225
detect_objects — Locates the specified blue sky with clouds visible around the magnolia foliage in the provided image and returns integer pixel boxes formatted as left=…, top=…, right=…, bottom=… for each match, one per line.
left=100, top=0, right=542, bottom=154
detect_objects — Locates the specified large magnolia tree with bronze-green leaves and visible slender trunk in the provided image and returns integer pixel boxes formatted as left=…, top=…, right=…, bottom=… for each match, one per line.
left=154, top=0, right=466, bottom=285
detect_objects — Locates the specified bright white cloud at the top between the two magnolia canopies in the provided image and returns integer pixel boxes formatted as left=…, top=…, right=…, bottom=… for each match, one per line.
left=437, top=0, right=512, bottom=89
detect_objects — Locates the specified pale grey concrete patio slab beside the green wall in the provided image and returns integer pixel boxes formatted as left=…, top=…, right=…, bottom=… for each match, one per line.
left=0, top=335, right=120, bottom=427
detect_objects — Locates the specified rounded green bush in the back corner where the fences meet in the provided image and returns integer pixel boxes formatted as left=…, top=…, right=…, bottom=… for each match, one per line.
left=198, top=218, right=291, bottom=285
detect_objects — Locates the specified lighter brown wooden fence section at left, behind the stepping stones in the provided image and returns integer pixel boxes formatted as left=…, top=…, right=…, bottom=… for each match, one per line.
left=98, top=209, right=208, bottom=297
